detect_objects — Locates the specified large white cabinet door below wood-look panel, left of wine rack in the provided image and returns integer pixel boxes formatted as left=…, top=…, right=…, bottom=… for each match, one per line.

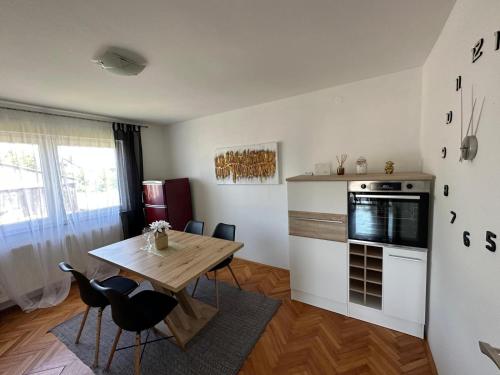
left=289, top=236, right=347, bottom=303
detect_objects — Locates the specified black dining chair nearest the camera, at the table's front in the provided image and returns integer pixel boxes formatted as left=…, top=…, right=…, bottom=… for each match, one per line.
left=90, top=280, right=177, bottom=375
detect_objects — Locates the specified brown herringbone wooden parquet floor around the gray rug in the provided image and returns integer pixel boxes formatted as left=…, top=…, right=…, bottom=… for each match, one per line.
left=0, top=259, right=436, bottom=375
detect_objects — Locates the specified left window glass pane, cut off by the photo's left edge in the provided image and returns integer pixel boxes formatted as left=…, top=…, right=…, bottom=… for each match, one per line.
left=0, top=142, right=47, bottom=225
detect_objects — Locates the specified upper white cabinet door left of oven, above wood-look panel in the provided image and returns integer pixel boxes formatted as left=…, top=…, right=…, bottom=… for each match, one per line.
left=287, top=181, right=347, bottom=215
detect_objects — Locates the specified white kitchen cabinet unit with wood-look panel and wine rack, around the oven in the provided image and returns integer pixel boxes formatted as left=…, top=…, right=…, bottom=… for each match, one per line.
left=288, top=180, right=427, bottom=337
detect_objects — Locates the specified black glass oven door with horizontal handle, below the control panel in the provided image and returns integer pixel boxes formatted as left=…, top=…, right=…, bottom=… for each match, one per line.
left=349, top=193, right=429, bottom=248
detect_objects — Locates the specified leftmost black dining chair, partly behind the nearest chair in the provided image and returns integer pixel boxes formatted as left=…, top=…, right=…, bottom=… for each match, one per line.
left=59, top=262, right=139, bottom=367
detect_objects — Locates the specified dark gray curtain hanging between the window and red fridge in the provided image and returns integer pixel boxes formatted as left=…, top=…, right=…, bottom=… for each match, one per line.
left=113, top=122, right=145, bottom=238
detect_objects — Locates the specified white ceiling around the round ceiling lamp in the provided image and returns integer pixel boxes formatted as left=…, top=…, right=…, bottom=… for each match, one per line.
left=0, top=0, right=454, bottom=123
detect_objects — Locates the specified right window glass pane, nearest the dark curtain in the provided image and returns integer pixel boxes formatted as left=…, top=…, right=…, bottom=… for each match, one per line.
left=57, top=146, right=120, bottom=213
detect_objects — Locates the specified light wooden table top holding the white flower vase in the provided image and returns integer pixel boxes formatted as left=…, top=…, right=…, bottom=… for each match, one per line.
left=89, top=230, right=243, bottom=293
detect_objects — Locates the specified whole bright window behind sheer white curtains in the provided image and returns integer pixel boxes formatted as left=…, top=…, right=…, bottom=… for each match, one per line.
left=0, top=133, right=120, bottom=231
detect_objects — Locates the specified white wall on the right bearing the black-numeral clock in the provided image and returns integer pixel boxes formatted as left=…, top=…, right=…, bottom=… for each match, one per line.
left=421, top=0, right=500, bottom=375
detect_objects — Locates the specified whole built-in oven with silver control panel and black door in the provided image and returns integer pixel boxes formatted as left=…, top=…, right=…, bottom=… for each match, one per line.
left=348, top=181, right=431, bottom=248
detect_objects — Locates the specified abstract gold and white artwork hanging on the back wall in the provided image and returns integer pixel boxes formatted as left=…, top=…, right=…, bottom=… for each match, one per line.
left=214, top=142, right=280, bottom=184
